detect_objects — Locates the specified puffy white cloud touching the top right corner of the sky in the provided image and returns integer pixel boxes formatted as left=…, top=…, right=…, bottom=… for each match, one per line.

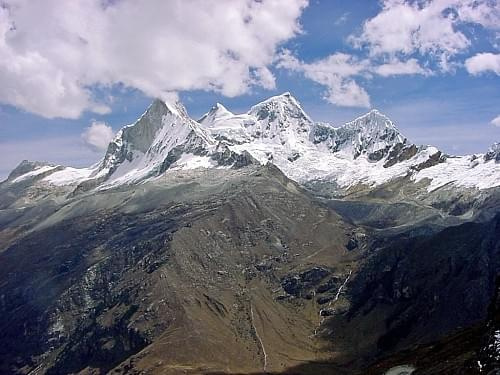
left=350, top=0, right=500, bottom=71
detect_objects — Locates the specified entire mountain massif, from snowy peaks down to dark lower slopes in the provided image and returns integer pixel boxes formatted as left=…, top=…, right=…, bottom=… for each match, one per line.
left=0, top=94, right=500, bottom=374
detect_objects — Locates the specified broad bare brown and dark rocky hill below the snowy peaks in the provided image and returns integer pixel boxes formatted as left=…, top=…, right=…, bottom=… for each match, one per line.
left=0, top=167, right=360, bottom=373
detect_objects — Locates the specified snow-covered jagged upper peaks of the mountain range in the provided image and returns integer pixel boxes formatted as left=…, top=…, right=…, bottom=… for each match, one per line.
left=7, top=93, right=500, bottom=194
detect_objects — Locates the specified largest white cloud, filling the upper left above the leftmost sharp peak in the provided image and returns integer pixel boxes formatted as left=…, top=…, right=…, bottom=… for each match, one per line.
left=0, top=0, right=307, bottom=118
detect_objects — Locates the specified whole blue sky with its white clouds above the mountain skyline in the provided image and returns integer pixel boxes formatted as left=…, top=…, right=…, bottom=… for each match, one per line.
left=0, top=0, right=500, bottom=178
